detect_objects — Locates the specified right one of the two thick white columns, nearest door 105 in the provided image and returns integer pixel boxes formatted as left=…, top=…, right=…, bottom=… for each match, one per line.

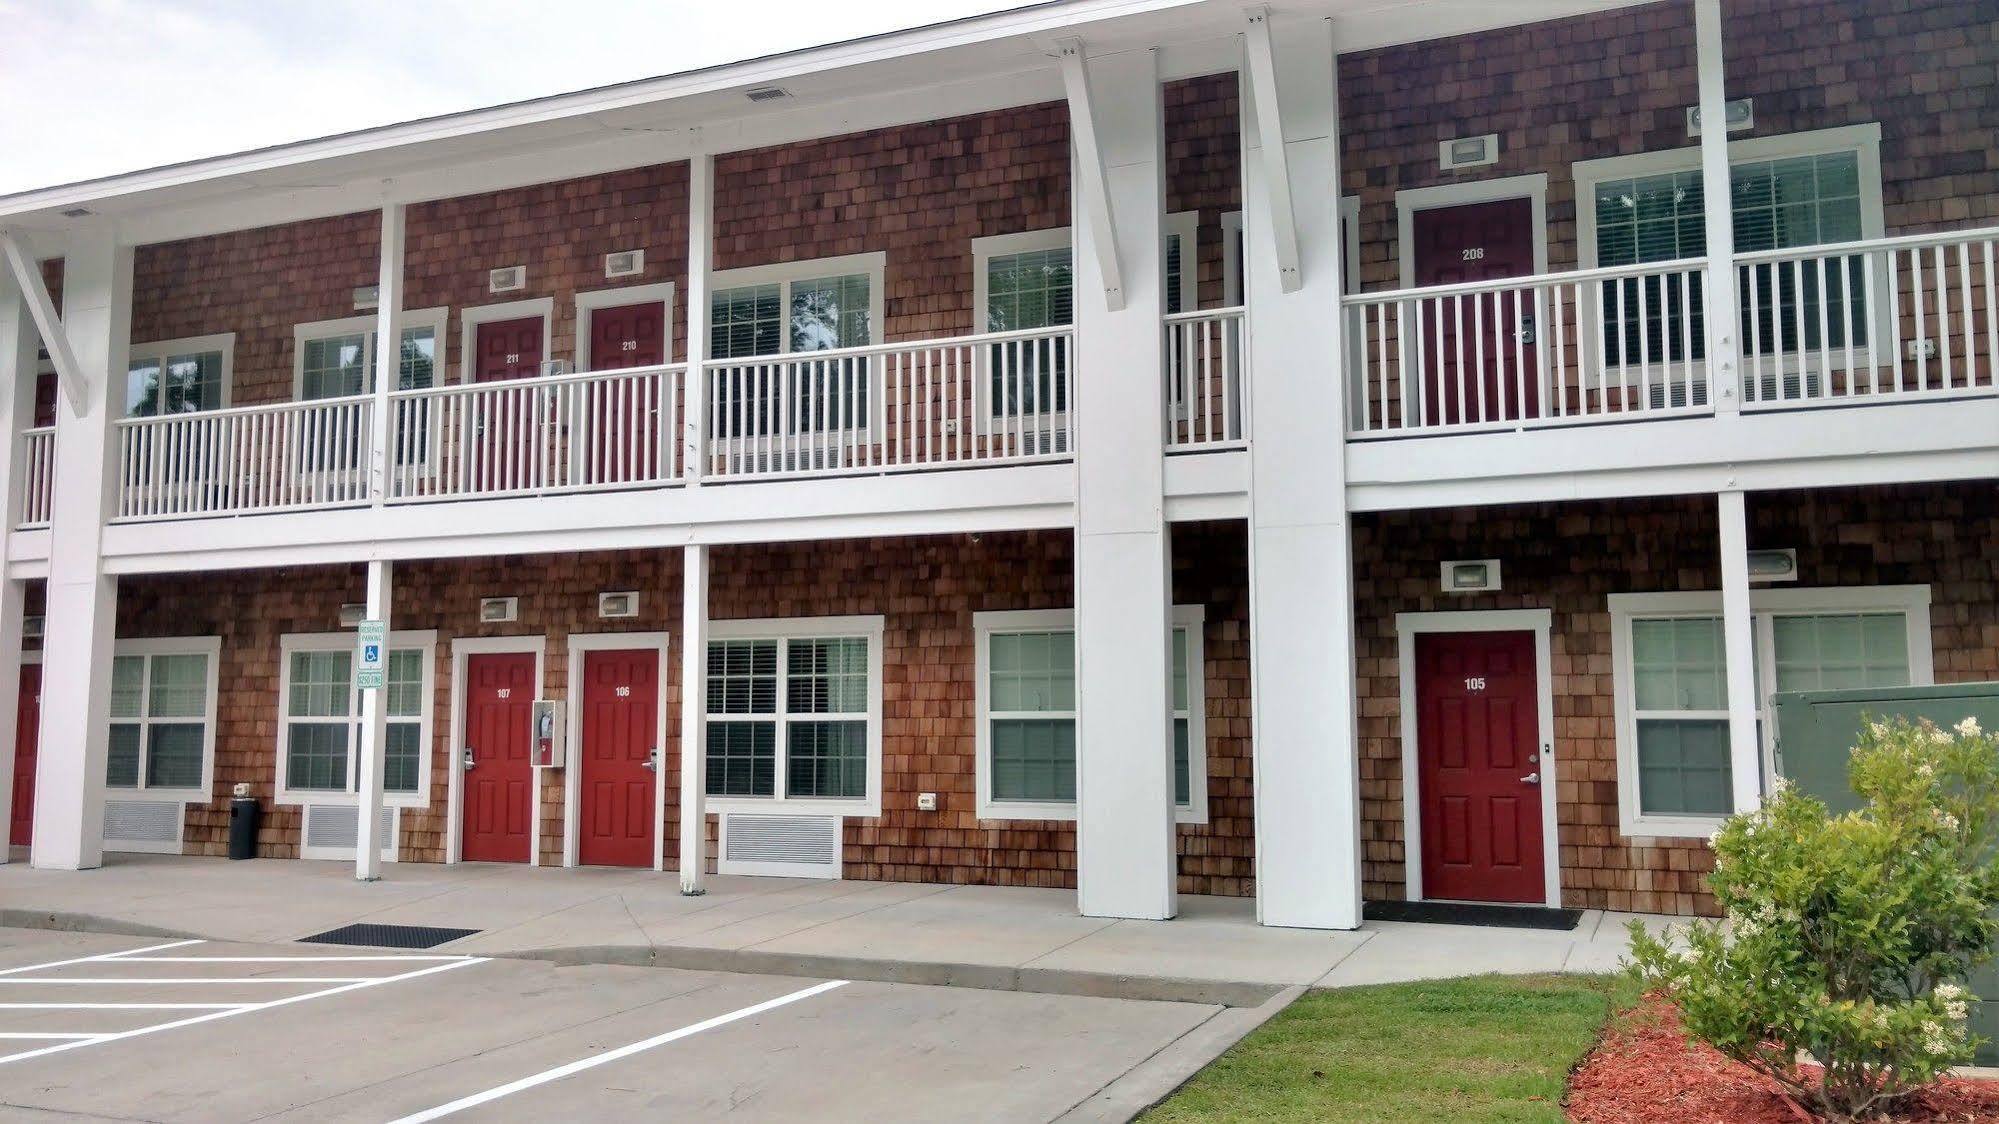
left=1243, top=12, right=1361, bottom=928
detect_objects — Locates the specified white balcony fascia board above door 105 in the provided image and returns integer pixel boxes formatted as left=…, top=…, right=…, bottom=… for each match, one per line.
left=1347, top=398, right=1999, bottom=510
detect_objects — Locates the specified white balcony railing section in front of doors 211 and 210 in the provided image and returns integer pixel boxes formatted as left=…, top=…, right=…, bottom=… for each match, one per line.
left=388, top=364, right=686, bottom=502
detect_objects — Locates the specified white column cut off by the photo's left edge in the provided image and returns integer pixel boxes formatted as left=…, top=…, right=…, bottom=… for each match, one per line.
left=0, top=268, right=40, bottom=862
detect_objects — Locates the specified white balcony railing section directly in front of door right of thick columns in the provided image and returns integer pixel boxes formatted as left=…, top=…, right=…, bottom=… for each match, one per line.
left=1341, top=258, right=1709, bottom=438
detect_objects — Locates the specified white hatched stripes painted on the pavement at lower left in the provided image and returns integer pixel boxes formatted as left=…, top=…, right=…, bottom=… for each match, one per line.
left=0, top=940, right=486, bottom=1066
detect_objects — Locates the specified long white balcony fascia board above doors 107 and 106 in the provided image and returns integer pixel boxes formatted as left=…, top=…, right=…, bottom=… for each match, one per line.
left=104, top=462, right=1075, bottom=574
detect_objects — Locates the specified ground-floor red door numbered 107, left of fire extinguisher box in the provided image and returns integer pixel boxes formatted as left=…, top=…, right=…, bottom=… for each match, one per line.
left=460, top=652, right=534, bottom=862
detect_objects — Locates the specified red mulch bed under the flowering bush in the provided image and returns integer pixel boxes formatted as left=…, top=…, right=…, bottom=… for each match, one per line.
left=1567, top=998, right=1999, bottom=1124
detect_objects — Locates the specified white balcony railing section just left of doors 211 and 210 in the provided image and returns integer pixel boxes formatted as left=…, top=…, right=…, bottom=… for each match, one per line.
left=116, top=396, right=374, bottom=520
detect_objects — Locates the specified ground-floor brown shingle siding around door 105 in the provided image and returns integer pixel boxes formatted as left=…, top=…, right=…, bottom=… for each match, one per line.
left=1353, top=484, right=1999, bottom=914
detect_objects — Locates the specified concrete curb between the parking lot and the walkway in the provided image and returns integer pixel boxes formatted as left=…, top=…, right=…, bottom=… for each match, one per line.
left=0, top=908, right=1283, bottom=1008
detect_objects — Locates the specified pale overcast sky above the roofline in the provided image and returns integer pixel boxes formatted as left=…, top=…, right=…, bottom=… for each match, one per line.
left=0, top=0, right=1025, bottom=194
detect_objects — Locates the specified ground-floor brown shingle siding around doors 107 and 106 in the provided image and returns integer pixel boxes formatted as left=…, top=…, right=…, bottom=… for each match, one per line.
left=105, top=522, right=1253, bottom=896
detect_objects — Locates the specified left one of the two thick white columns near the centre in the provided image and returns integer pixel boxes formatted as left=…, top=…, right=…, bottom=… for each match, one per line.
left=1065, top=44, right=1179, bottom=920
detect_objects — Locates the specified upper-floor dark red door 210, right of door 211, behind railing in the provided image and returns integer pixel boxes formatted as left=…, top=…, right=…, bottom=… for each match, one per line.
left=578, top=300, right=666, bottom=484
